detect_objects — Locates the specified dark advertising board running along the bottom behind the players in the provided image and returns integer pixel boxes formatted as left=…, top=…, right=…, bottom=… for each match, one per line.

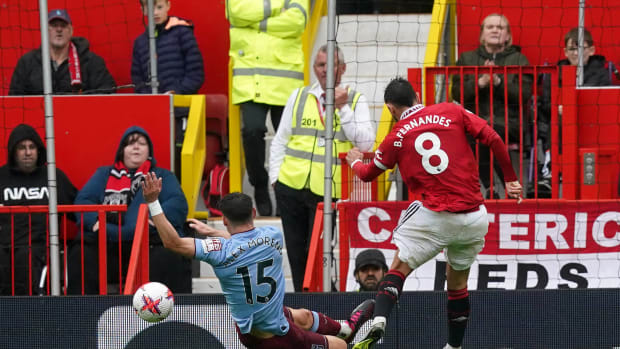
left=0, top=289, right=620, bottom=349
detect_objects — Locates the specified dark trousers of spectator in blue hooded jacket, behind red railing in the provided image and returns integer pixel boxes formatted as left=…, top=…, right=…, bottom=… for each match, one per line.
left=67, top=237, right=192, bottom=294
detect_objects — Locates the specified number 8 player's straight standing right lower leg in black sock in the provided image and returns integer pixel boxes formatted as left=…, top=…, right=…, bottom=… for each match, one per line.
left=444, top=264, right=469, bottom=349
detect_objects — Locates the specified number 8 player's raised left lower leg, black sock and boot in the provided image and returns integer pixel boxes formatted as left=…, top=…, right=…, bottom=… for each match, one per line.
left=353, top=251, right=413, bottom=349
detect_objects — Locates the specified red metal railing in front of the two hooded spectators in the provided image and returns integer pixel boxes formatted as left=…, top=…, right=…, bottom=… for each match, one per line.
left=0, top=205, right=149, bottom=296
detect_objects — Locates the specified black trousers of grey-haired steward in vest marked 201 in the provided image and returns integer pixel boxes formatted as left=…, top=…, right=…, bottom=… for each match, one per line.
left=275, top=182, right=323, bottom=292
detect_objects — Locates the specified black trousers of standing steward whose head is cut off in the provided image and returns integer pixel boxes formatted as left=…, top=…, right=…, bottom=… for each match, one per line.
left=240, top=102, right=284, bottom=188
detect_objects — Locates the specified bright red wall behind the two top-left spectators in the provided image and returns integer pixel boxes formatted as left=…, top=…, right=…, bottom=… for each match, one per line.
left=0, top=0, right=229, bottom=95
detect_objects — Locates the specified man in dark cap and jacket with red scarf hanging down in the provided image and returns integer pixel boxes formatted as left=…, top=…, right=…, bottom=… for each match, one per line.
left=9, top=9, right=116, bottom=95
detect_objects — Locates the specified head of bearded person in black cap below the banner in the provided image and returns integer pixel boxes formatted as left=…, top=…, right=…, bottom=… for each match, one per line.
left=353, top=248, right=388, bottom=292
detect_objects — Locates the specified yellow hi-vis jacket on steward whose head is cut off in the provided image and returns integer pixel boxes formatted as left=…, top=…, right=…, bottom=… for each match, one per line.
left=226, top=0, right=308, bottom=106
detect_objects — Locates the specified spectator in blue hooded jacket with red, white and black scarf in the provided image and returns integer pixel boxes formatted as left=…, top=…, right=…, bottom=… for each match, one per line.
left=69, top=126, right=192, bottom=294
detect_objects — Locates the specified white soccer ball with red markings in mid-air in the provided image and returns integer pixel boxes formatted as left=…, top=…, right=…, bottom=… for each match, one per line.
left=133, top=282, right=174, bottom=322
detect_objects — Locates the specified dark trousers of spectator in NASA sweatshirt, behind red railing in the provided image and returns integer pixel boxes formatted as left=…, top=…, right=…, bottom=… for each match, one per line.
left=0, top=242, right=46, bottom=296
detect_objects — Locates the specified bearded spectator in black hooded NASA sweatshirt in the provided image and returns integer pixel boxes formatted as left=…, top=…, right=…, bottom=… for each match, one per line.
left=0, top=124, right=77, bottom=296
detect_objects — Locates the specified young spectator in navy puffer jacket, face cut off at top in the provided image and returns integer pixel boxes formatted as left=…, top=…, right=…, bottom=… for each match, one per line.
left=131, top=0, right=205, bottom=178
